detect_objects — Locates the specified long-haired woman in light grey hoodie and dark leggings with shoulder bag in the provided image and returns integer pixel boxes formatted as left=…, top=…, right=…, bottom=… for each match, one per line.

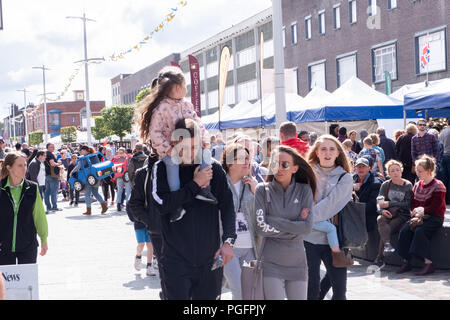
left=305, top=135, right=353, bottom=300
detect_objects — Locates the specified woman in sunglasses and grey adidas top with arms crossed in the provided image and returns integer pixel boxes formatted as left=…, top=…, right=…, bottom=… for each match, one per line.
left=253, top=146, right=316, bottom=300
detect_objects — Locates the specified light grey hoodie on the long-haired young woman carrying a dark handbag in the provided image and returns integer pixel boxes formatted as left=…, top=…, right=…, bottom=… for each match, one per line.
left=305, top=165, right=353, bottom=245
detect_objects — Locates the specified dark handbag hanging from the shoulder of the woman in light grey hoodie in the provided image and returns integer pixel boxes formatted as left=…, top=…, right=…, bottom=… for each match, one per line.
left=334, top=173, right=369, bottom=249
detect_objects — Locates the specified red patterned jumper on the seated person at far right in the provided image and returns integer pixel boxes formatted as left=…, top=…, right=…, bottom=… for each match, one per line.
left=411, top=178, right=446, bottom=218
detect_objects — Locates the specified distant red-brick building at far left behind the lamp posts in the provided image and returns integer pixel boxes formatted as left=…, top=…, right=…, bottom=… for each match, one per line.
left=28, top=90, right=105, bottom=137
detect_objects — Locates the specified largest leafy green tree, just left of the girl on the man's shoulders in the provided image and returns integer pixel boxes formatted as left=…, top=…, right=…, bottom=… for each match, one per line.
left=102, top=105, right=134, bottom=141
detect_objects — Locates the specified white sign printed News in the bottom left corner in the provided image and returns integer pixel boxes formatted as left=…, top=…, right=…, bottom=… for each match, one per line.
left=0, top=264, right=39, bottom=300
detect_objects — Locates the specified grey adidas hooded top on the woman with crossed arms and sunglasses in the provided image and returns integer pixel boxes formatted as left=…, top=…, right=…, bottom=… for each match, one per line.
left=253, top=179, right=313, bottom=281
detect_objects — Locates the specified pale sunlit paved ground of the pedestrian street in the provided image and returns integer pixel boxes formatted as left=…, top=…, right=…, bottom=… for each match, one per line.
left=38, top=198, right=450, bottom=300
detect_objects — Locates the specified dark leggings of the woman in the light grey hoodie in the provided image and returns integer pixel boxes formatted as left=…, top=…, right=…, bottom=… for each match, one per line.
left=304, top=241, right=347, bottom=300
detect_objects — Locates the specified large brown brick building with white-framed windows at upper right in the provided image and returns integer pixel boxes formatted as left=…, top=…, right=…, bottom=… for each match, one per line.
left=283, top=0, right=450, bottom=96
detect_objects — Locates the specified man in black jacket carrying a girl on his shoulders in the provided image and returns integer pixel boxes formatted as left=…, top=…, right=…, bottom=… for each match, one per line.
left=153, top=119, right=236, bottom=300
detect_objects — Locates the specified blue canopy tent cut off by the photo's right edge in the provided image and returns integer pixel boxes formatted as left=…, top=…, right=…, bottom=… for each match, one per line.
left=404, top=79, right=450, bottom=118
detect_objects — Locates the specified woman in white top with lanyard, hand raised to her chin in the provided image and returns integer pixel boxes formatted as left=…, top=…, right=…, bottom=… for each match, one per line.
left=222, top=144, right=256, bottom=300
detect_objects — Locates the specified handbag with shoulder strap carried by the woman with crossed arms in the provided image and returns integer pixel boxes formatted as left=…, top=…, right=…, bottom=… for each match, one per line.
left=241, top=184, right=270, bottom=300
